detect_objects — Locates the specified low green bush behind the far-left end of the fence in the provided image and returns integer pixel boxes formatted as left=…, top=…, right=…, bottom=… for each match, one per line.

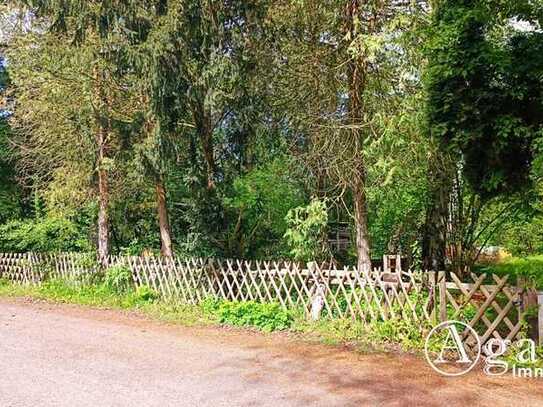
left=0, top=217, right=91, bottom=252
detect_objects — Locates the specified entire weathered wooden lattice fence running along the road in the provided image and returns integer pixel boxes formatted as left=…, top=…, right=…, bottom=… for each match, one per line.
left=0, top=253, right=536, bottom=342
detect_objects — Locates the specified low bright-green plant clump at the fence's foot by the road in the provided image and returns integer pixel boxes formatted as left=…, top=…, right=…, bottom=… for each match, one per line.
left=203, top=300, right=293, bottom=332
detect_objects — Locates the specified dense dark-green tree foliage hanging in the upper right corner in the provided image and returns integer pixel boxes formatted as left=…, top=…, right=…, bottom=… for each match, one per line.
left=426, top=0, right=543, bottom=198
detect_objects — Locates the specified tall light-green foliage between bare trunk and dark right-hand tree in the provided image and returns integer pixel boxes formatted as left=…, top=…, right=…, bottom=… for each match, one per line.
left=366, top=90, right=431, bottom=258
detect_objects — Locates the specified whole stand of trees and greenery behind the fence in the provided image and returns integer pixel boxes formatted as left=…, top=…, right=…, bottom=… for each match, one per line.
left=0, top=0, right=543, bottom=270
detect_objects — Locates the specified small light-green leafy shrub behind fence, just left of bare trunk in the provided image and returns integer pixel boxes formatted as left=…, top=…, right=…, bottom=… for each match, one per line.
left=284, top=198, right=328, bottom=261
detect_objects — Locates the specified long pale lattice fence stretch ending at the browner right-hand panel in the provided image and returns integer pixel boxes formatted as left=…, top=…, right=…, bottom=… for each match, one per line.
left=105, top=257, right=434, bottom=321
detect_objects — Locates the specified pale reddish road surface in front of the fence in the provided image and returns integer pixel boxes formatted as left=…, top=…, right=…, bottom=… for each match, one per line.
left=0, top=299, right=543, bottom=407
